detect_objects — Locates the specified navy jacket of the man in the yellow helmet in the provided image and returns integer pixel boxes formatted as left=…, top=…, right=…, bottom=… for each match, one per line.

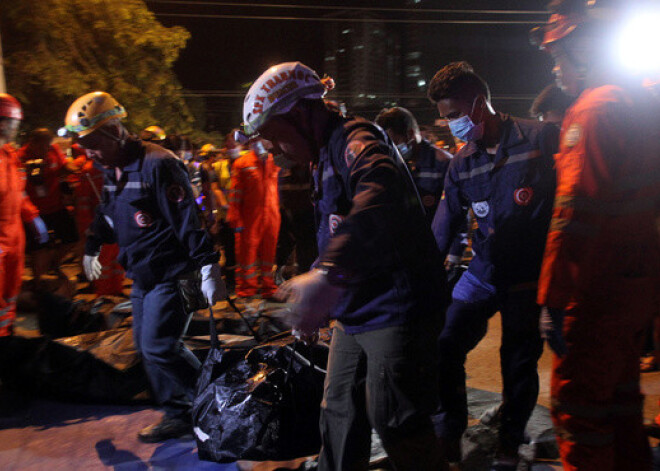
left=85, top=139, right=219, bottom=288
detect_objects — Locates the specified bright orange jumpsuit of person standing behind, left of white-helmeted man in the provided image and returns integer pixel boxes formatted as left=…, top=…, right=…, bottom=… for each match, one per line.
left=227, top=151, right=280, bottom=298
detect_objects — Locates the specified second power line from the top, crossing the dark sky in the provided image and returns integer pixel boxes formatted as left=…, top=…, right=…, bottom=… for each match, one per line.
left=155, top=13, right=546, bottom=25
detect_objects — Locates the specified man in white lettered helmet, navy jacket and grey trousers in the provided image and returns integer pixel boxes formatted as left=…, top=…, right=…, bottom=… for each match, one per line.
left=243, top=62, right=447, bottom=471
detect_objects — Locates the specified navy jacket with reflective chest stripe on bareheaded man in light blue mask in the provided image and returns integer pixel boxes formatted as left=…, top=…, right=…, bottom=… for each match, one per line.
left=432, top=115, right=557, bottom=288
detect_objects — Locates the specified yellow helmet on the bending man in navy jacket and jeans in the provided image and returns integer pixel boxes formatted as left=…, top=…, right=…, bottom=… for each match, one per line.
left=65, top=92, right=128, bottom=137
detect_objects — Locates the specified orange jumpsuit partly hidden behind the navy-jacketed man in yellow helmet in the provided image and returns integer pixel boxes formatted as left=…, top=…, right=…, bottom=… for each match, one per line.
left=73, top=155, right=124, bottom=296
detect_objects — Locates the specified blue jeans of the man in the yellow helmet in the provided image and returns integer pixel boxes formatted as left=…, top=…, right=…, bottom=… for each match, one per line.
left=131, top=281, right=200, bottom=416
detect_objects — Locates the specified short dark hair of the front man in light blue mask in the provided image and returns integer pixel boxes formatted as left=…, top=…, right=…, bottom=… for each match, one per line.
left=427, top=62, right=490, bottom=103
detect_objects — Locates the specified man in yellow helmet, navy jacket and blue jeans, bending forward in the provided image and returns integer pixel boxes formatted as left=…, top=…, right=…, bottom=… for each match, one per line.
left=66, top=92, right=225, bottom=442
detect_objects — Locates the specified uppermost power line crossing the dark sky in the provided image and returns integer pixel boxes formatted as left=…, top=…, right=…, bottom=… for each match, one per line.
left=146, top=0, right=548, bottom=15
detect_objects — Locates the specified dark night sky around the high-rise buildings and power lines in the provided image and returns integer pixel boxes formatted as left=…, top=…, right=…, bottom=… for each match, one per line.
left=146, top=0, right=551, bottom=132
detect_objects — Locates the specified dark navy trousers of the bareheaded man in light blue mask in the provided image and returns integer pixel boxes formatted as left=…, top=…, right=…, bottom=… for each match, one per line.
left=434, top=273, right=543, bottom=448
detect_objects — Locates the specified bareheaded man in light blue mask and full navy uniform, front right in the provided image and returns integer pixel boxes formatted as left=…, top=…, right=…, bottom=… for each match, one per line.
left=428, top=62, right=556, bottom=471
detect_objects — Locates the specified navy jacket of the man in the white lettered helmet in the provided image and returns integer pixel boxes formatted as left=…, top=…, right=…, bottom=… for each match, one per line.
left=314, top=116, right=444, bottom=333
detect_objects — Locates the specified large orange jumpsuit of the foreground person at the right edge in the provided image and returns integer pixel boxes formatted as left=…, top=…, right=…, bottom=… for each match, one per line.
left=538, top=85, right=660, bottom=471
